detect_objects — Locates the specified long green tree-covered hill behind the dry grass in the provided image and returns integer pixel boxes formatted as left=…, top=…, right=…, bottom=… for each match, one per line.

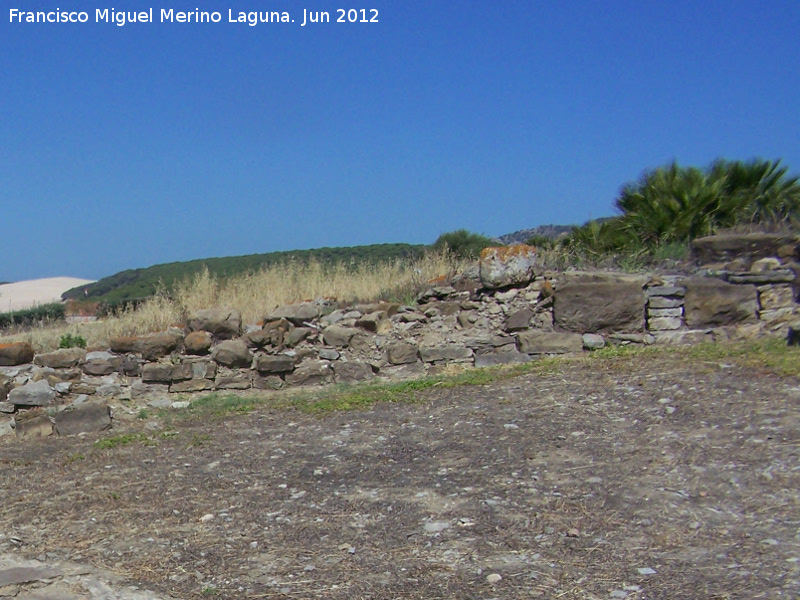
left=61, top=244, right=427, bottom=304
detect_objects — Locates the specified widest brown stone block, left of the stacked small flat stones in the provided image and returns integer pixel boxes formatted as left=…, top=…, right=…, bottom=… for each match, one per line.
left=553, top=278, right=645, bottom=333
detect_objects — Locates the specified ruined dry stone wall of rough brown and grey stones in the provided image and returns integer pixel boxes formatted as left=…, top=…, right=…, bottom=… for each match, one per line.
left=0, top=234, right=800, bottom=438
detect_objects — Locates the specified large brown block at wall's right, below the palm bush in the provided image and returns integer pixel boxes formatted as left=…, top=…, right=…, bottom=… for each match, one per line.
left=683, top=278, right=758, bottom=329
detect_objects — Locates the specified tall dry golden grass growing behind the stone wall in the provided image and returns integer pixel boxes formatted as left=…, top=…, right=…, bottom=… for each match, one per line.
left=0, top=253, right=466, bottom=352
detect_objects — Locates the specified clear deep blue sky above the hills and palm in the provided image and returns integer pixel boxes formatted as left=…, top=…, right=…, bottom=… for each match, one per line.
left=0, top=0, right=800, bottom=281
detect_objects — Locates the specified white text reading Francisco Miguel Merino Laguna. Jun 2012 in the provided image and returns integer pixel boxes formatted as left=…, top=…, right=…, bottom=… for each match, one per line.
left=9, top=8, right=379, bottom=27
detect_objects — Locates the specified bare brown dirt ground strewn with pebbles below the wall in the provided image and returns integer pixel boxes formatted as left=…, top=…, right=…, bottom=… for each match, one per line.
left=0, top=354, right=800, bottom=600
